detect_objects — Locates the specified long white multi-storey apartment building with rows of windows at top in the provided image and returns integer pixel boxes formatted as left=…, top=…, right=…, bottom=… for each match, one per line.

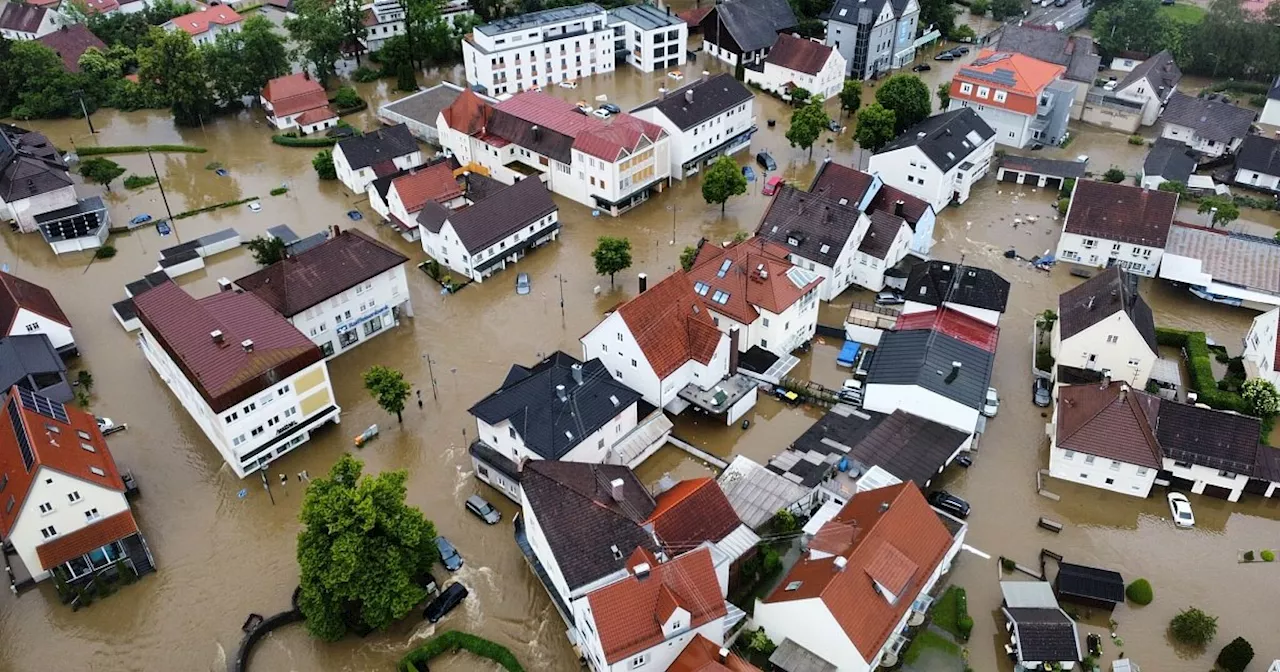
left=462, top=3, right=614, bottom=100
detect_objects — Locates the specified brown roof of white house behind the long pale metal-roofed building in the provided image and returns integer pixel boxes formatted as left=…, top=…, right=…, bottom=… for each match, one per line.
left=1065, top=179, right=1178, bottom=248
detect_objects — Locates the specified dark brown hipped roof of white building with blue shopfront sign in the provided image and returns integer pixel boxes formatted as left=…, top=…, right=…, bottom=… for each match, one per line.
left=236, top=227, right=404, bottom=317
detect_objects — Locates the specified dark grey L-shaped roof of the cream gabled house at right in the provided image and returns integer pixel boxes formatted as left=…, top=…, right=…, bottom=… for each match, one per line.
left=1057, top=266, right=1157, bottom=352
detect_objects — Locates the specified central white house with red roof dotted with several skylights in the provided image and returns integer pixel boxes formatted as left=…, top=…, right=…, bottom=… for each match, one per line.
left=686, top=237, right=822, bottom=357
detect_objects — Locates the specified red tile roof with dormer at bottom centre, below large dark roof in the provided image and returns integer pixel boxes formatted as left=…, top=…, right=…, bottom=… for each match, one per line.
left=586, top=548, right=727, bottom=664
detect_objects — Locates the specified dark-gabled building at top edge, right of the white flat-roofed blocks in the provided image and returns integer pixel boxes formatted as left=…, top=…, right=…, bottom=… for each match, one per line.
left=700, top=0, right=797, bottom=65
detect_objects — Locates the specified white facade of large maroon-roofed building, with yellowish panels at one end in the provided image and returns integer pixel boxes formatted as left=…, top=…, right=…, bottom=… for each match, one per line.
left=138, top=326, right=342, bottom=479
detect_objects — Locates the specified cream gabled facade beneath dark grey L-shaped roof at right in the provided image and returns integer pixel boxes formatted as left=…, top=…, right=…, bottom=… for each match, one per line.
left=1050, top=310, right=1157, bottom=389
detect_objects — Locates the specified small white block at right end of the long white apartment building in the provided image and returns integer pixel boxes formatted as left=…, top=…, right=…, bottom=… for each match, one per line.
left=608, top=3, right=689, bottom=73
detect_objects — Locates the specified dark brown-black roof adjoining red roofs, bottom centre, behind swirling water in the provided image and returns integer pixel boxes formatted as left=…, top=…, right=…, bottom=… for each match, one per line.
left=520, top=460, right=659, bottom=590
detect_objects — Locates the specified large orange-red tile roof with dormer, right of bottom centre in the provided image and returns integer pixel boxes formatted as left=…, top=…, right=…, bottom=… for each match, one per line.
left=762, top=483, right=954, bottom=657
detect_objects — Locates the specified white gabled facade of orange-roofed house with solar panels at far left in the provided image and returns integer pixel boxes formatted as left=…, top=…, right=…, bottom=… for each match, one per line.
left=6, top=465, right=129, bottom=581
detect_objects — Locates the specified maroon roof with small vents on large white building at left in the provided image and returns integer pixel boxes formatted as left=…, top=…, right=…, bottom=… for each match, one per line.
left=133, top=283, right=324, bottom=413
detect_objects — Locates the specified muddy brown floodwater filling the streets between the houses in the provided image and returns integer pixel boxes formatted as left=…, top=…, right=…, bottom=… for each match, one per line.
left=0, top=31, right=1280, bottom=672
